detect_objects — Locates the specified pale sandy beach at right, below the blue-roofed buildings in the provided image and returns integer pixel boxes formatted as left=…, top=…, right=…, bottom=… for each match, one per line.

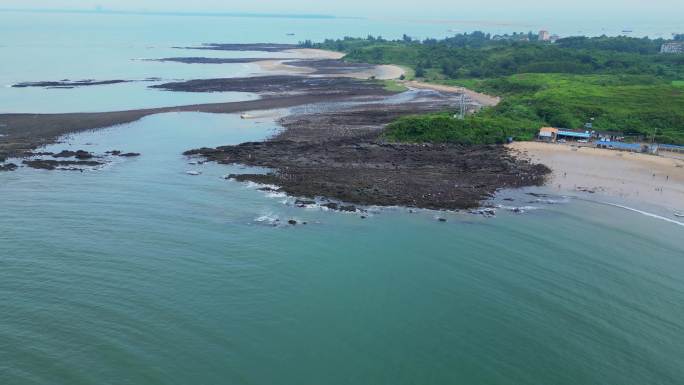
left=509, top=142, right=684, bottom=212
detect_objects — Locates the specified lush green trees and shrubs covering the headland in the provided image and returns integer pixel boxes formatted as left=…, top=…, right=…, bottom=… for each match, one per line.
left=308, top=32, right=684, bottom=144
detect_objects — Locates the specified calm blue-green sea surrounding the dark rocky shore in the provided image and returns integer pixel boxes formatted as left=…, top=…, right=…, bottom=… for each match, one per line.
left=0, top=13, right=684, bottom=385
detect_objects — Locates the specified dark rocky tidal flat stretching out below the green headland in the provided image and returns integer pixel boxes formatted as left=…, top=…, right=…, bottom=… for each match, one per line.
left=0, top=44, right=549, bottom=210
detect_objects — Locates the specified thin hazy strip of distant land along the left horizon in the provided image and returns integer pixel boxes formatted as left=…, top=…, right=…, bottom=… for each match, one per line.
left=0, top=8, right=363, bottom=19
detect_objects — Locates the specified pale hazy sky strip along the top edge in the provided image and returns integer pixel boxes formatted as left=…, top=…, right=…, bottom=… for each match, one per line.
left=5, top=0, right=684, bottom=20
